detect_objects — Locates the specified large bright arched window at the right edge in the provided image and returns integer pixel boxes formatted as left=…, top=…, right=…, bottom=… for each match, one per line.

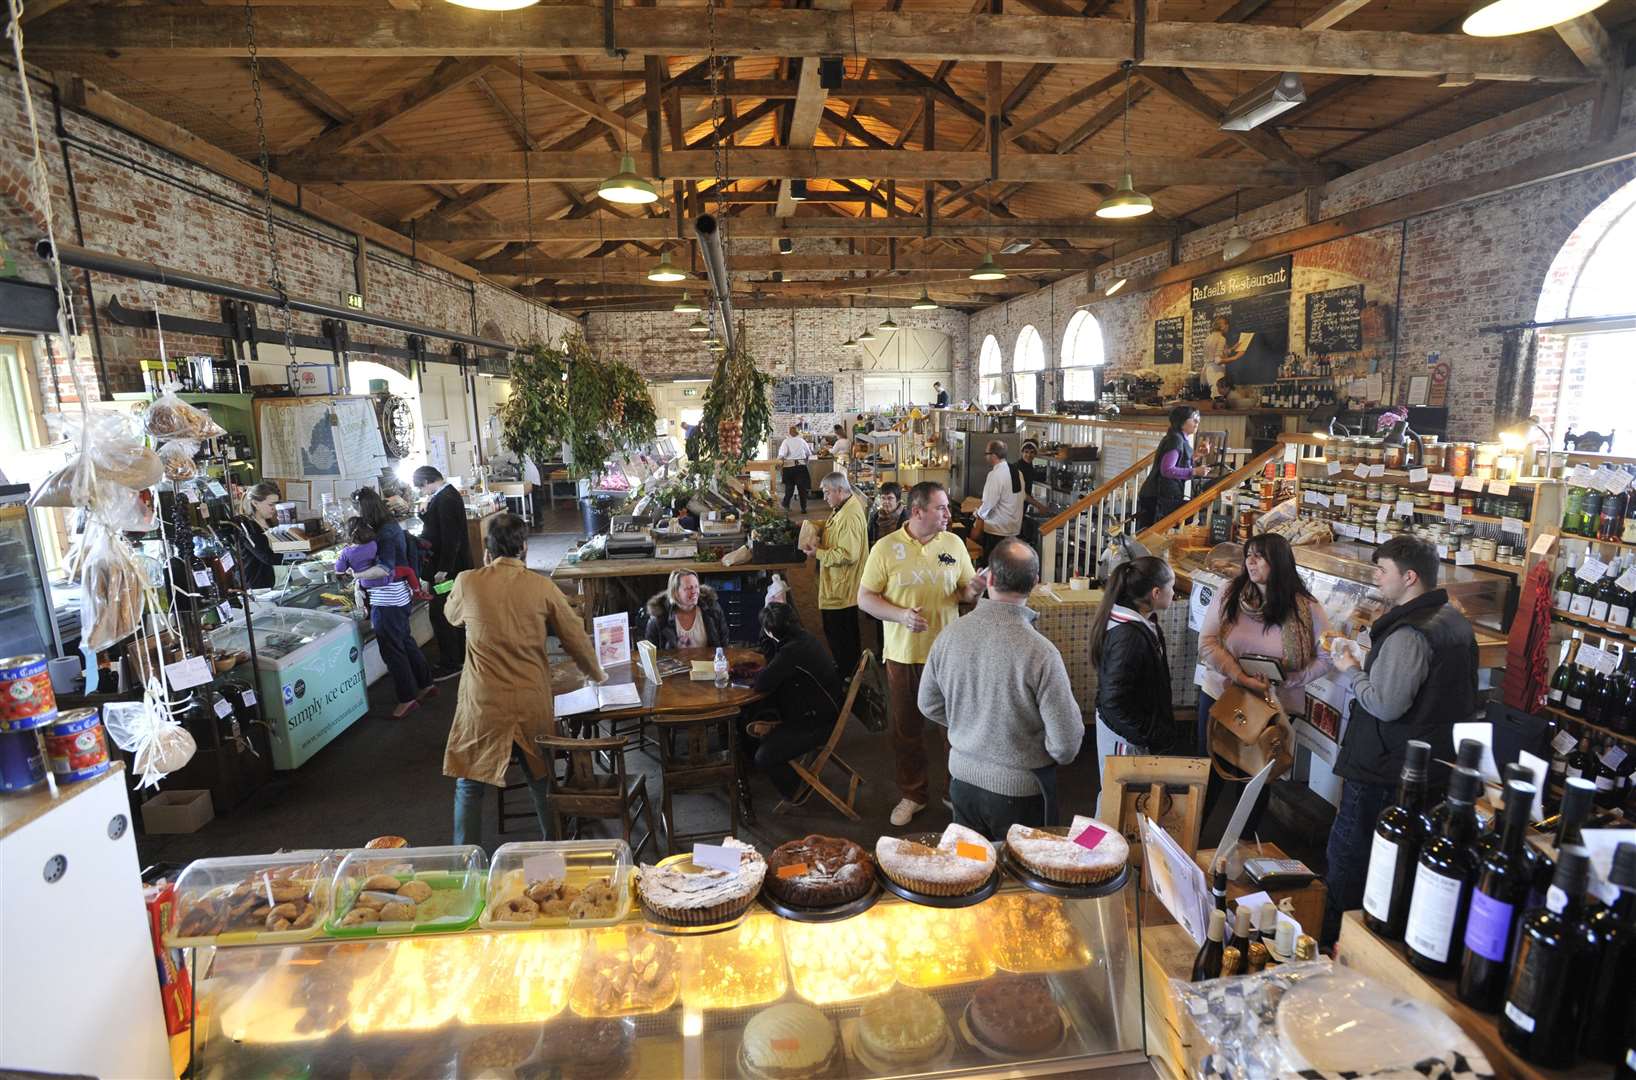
left=1531, top=182, right=1636, bottom=453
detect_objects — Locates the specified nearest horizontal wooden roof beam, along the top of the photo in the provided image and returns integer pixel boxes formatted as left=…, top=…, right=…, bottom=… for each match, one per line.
left=29, top=5, right=1585, bottom=82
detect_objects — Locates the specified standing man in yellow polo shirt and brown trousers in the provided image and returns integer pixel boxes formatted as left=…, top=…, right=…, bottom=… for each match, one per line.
left=857, top=481, right=988, bottom=828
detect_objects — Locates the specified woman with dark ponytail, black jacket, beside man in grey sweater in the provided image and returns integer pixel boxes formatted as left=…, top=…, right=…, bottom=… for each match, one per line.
left=1090, top=555, right=1188, bottom=817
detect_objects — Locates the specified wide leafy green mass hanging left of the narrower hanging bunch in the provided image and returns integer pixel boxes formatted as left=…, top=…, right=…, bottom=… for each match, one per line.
left=499, top=334, right=659, bottom=476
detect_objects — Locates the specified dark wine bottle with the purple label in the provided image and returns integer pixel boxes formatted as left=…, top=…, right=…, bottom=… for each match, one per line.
left=1459, top=782, right=1535, bottom=1013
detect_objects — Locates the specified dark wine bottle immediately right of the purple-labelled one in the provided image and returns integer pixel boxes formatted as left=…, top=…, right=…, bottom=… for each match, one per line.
left=1500, top=848, right=1593, bottom=1069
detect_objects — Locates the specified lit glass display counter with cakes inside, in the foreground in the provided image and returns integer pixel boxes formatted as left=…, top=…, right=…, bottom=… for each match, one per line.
left=190, top=875, right=1147, bottom=1080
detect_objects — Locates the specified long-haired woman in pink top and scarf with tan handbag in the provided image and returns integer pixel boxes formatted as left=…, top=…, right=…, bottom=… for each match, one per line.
left=1199, top=533, right=1330, bottom=825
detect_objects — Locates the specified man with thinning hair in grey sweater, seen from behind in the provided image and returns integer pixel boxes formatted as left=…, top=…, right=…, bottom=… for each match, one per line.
left=919, top=538, right=1085, bottom=841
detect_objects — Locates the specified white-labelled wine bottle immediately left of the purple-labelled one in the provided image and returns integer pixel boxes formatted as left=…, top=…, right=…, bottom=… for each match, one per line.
left=1404, top=769, right=1482, bottom=977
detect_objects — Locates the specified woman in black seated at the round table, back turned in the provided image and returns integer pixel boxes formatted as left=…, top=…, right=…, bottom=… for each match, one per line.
left=739, top=602, right=843, bottom=820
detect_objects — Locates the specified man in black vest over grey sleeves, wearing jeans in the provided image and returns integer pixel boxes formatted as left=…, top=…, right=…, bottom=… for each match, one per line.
left=1319, top=537, right=1477, bottom=947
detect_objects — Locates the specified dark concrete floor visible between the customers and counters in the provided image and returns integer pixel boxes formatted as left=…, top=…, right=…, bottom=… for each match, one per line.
left=137, top=502, right=1322, bottom=869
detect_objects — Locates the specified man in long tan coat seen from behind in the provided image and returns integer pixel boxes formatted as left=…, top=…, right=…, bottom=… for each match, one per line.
left=443, top=514, right=607, bottom=844
